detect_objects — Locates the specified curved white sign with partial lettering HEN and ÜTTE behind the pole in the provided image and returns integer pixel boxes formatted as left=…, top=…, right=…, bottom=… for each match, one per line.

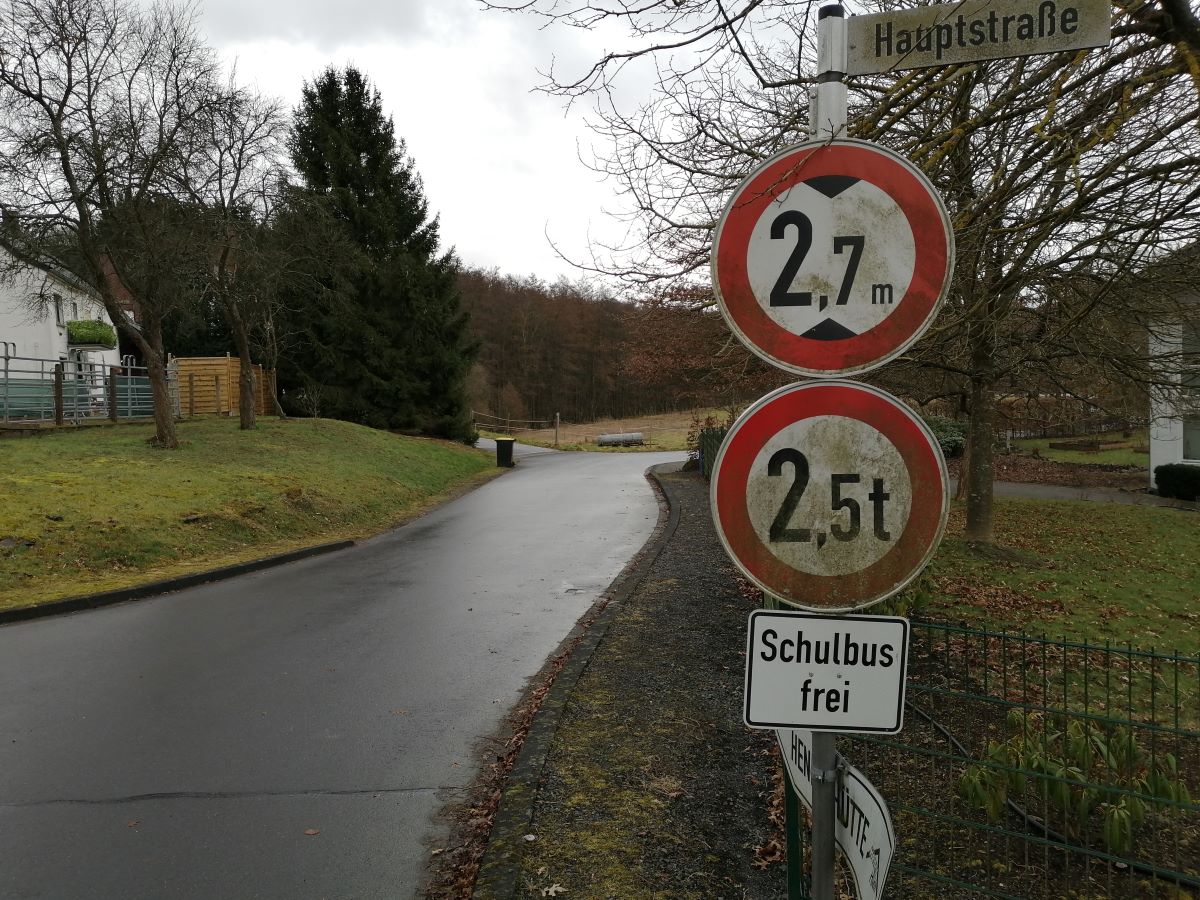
left=775, top=728, right=896, bottom=900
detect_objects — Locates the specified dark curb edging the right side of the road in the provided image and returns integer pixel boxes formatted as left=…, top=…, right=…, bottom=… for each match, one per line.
left=472, top=463, right=679, bottom=900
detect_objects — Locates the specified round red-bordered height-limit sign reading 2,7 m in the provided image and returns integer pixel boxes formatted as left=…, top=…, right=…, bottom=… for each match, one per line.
left=712, top=140, right=954, bottom=377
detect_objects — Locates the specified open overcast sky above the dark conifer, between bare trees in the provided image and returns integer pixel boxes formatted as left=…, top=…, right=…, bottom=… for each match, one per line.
left=199, top=0, right=648, bottom=281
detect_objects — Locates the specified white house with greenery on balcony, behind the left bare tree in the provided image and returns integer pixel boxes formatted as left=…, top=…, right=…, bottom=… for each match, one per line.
left=0, top=246, right=121, bottom=377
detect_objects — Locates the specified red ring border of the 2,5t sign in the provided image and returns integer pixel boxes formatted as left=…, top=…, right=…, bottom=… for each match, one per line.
left=709, top=380, right=949, bottom=613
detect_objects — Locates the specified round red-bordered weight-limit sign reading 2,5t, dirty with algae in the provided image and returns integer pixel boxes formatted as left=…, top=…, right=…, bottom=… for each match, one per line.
left=709, top=382, right=949, bottom=612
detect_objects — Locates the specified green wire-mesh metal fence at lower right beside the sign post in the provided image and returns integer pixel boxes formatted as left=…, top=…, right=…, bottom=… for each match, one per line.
left=816, top=622, right=1200, bottom=900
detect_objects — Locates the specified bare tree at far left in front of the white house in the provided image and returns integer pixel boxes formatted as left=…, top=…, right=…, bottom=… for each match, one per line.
left=0, top=0, right=221, bottom=448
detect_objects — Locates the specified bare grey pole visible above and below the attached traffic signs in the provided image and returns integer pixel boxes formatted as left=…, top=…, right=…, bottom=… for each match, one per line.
left=810, top=4, right=846, bottom=900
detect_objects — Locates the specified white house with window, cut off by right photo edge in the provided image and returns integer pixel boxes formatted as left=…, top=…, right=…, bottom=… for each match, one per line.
left=1150, top=294, right=1200, bottom=486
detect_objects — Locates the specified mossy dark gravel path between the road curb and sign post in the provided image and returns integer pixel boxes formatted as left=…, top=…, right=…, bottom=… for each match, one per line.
left=475, top=473, right=786, bottom=900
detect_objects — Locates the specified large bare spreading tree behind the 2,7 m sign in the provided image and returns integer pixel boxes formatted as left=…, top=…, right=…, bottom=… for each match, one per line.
left=482, top=0, right=1200, bottom=542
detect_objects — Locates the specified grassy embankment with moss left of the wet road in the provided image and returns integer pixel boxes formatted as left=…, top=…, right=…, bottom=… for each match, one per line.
left=0, top=419, right=498, bottom=608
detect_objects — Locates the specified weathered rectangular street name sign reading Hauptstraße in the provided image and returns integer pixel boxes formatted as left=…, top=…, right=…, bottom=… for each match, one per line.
left=846, top=0, right=1112, bottom=76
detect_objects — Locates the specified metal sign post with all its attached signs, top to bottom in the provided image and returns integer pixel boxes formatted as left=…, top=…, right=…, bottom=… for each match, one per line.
left=710, top=0, right=1109, bottom=900
